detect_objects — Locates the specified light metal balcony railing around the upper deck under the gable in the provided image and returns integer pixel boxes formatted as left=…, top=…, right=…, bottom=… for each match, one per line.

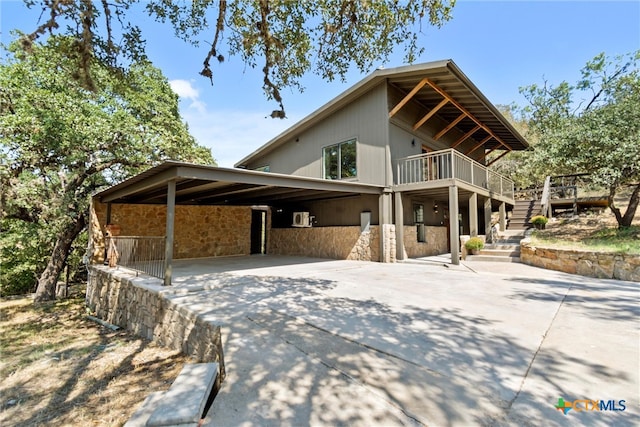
left=396, top=149, right=514, bottom=199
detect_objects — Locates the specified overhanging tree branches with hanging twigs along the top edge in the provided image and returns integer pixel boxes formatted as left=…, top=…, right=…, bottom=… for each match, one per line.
left=22, top=0, right=455, bottom=118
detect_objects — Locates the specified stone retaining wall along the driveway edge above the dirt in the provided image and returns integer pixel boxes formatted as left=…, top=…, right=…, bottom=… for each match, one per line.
left=86, top=265, right=225, bottom=381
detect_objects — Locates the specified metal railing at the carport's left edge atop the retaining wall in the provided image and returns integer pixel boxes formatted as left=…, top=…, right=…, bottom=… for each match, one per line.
left=106, top=236, right=165, bottom=279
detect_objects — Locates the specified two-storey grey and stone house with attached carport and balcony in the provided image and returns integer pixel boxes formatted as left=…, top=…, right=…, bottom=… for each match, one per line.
left=91, top=60, right=527, bottom=283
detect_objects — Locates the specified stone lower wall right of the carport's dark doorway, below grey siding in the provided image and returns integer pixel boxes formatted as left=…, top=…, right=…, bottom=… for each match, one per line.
left=267, top=225, right=390, bottom=261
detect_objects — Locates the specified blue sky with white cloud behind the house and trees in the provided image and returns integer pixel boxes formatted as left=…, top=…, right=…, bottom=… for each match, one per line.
left=0, top=0, right=640, bottom=167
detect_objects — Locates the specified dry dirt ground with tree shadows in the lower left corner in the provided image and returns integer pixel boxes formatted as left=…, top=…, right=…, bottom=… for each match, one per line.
left=0, top=286, right=189, bottom=426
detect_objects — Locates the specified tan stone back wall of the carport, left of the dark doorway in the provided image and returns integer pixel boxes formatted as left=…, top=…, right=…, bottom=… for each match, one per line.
left=90, top=199, right=251, bottom=262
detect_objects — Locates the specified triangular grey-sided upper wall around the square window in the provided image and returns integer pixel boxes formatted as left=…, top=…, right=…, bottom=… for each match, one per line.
left=242, top=84, right=391, bottom=185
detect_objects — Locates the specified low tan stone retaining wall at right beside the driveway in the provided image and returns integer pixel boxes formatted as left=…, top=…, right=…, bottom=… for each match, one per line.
left=520, top=239, right=640, bottom=282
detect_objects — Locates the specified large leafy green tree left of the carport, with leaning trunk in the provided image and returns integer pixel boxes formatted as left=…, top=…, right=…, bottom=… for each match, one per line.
left=0, top=36, right=213, bottom=301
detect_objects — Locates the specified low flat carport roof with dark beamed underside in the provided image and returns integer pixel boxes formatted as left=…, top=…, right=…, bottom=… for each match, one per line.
left=94, top=161, right=384, bottom=205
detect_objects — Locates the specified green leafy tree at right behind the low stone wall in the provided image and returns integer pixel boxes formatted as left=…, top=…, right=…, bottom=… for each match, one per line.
left=521, top=51, right=640, bottom=228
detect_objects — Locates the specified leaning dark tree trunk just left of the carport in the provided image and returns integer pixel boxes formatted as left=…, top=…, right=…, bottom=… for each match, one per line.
left=35, top=213, right=87, bottom=302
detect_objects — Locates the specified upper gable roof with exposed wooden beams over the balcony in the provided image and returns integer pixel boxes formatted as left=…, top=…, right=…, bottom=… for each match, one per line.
left=235, top=59, right=529, bottom=167
